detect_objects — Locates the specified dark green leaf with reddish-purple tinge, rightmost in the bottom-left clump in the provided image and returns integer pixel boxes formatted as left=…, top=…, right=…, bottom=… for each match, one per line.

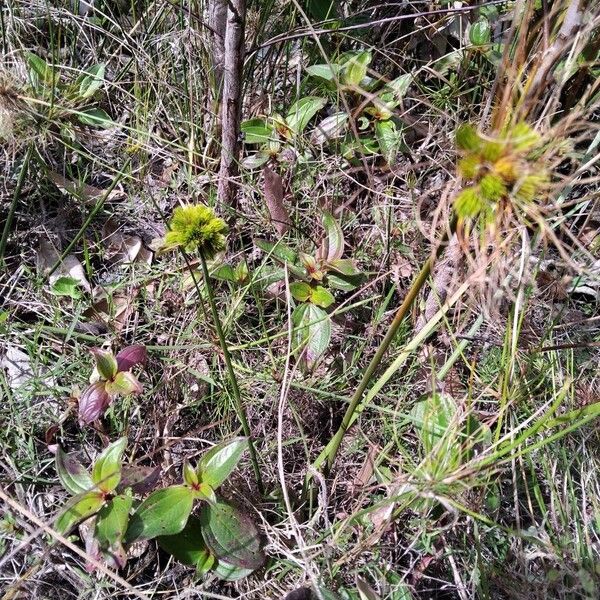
left=200, top=500, right=265, bottom=570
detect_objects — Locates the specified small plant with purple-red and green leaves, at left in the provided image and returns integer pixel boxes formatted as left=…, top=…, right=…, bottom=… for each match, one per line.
left=79, top=344, right=148, bottom=425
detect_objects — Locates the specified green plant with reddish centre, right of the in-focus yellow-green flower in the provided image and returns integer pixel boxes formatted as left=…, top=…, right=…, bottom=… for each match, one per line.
left=255, top=213, right=363, bottom=371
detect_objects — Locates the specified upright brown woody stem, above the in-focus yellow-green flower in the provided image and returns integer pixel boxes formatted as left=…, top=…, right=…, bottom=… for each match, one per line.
left=217, top=0, right=246, bottom=206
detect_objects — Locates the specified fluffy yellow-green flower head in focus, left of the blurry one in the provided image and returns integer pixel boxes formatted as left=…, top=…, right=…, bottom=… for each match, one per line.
left=165, top=204, right=227, bottom=259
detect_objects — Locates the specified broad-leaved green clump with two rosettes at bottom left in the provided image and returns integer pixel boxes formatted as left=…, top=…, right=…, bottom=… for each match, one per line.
left=55, top=438, right=264, bottom=579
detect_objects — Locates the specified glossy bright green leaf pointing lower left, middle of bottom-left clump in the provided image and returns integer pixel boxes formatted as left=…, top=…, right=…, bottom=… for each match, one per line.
left=126, top=485, right=194, bottom=544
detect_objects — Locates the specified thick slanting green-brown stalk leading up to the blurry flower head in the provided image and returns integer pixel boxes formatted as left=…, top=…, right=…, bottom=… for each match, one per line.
left=313, top=217, right=457, bottom=471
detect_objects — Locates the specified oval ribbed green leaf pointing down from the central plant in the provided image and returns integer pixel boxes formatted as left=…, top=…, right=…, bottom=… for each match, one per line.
left=292, top=303, right=331, bottom=371
